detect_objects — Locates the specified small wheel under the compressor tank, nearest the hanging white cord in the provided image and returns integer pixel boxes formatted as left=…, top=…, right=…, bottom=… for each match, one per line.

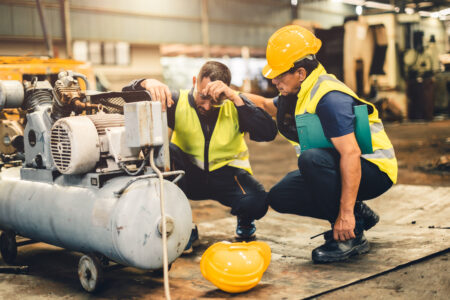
left=78, top=254, right=103, bottom=293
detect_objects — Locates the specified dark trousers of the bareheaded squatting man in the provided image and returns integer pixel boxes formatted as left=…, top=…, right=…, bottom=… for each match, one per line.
left=170, top=143, right=268, bottom=221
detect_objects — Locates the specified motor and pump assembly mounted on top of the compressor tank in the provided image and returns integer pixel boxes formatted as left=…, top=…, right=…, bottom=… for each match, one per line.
left=0, top=71, right=168, bottom=182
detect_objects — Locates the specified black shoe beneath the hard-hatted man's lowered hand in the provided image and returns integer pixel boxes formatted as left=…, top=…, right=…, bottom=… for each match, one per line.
left=312, top=230, right=370, bottom=263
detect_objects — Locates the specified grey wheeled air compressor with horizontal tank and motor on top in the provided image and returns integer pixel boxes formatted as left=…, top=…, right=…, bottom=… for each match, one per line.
left=0, top=71, right=192, bottom=292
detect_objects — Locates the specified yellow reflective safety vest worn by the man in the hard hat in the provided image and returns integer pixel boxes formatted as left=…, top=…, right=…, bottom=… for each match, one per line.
left=295, top=65, right=398, bottom=183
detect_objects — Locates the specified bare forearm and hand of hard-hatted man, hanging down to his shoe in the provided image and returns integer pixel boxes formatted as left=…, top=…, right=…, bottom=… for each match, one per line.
left=331, top=132, right=361, bottom=241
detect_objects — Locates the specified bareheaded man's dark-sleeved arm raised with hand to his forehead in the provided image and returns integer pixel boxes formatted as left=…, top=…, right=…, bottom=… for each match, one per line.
left=202, top=81, right=277, bottom=142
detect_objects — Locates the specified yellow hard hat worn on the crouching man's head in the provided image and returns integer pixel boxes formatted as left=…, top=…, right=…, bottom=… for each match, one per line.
left=262, top=25, right=322, bottom=79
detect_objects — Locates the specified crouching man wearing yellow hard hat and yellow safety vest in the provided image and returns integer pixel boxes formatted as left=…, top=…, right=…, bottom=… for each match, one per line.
left=247, top=25, right=397, bottom=263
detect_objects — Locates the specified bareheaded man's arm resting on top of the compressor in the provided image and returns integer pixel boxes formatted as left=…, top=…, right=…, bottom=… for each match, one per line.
left=122, top=79, right=179, bottom=129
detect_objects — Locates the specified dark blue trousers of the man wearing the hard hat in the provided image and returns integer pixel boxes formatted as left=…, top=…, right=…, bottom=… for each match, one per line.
left=268, top=148, right=392, bottom=223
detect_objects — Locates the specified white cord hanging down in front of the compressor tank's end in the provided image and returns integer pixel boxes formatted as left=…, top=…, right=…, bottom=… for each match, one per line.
left=150, top=148, right=171, bottom=300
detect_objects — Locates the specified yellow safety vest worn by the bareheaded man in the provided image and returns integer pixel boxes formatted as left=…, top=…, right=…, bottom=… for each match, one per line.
left=171, top=90, right=253, bottom=174
